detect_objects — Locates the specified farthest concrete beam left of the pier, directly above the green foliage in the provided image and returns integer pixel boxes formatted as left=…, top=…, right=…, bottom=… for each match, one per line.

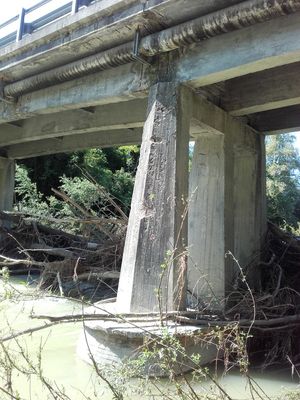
left=5, top=128, right=142, bottom=159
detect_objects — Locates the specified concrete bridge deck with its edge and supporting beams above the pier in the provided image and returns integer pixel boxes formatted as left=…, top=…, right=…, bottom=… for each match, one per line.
left=0, top=0, right=300, bottom=158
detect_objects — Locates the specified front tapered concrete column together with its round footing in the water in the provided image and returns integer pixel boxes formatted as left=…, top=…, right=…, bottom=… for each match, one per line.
left=79, top=82, right=216, bottom=376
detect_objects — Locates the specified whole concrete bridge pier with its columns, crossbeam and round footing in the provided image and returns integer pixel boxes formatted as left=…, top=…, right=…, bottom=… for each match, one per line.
left=80, top=82, right=265, bottom=375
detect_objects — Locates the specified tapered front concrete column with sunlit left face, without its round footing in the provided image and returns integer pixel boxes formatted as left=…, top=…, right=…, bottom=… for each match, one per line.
left=117, top=82, right=191, bottom=312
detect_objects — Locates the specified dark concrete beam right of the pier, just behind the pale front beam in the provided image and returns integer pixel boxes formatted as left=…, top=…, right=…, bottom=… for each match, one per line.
left=221, top=63, right=300, bottom=116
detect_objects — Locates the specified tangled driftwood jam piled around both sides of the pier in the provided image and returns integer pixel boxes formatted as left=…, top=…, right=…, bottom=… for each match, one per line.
left=0, top=209, right=300, bottom=365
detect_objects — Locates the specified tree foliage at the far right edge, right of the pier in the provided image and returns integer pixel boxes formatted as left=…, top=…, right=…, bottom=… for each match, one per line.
left=266, top=134, right=300, bottom=230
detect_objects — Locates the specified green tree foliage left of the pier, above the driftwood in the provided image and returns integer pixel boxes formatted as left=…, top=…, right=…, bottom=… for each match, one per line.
left=16, top=146, right=139, bottom=214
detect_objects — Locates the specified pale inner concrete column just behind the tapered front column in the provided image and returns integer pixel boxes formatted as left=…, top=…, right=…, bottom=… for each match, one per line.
left=188, top=132, right=225, bottom=308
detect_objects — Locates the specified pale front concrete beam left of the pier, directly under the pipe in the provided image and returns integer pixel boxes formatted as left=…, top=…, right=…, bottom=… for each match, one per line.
left=0, top=63, right=150, bottom=124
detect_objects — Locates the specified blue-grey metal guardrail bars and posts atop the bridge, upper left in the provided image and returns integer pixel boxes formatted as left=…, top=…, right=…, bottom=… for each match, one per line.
left=0, top=0, right=95, bottom=47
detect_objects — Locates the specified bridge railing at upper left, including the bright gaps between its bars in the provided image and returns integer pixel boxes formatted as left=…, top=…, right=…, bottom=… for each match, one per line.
left=0, top=0, right=95, bottom=47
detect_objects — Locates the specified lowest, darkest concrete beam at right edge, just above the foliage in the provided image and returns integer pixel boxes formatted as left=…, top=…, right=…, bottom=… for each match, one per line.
left=249, top=105, right=300, bottom=135
